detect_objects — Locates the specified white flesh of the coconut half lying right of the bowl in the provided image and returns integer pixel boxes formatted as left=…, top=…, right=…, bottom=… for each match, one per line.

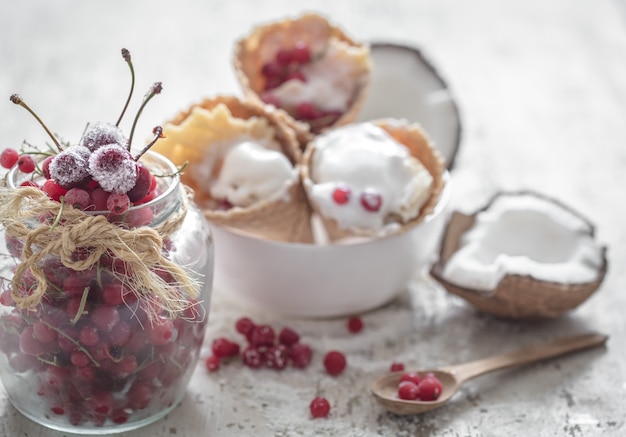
left=443, top=194, right=603, bottom=292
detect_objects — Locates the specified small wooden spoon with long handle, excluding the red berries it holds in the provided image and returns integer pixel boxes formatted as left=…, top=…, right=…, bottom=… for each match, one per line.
left=371, top=333, right=608, bottom=415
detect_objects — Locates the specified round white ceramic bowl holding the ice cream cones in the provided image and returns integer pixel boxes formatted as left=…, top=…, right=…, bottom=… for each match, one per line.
left=213, top=172, right=451, bottom=317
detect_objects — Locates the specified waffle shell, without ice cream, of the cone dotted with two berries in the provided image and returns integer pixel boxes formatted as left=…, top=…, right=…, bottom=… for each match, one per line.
left=300, top=119, right=445, bottom=241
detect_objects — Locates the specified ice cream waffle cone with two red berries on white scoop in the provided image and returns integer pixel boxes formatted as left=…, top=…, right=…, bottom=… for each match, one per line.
left=301, top=119, right=444, bottom=242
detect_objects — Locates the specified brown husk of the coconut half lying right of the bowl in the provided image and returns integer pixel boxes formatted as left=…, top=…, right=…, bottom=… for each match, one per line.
left=430, top=192, right=608, bottom=320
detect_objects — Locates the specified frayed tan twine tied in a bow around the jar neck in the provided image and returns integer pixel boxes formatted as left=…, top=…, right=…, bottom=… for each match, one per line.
left=0, top=187, right=199, bottom=315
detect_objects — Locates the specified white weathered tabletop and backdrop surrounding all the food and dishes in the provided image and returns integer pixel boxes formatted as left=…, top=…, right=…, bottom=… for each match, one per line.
left=0, top=0, right=626, bottom=437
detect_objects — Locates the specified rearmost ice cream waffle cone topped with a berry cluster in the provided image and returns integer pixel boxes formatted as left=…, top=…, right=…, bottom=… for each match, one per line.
left=234, top=14, right=372, bottom=138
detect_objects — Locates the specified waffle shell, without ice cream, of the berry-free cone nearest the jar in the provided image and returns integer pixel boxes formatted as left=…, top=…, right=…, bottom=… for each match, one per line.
left=154, top=96, right=313, bottom=243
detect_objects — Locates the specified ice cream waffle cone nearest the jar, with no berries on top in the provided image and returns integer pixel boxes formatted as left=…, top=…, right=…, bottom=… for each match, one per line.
left=154, top=96, right=312, bottom=243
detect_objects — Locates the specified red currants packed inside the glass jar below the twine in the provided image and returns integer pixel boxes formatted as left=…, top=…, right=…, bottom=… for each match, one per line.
left=0, top=257, right=205, bottom=426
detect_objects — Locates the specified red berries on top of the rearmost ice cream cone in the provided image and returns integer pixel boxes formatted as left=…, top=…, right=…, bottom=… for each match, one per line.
left=261, top=41, right=343, bottom=133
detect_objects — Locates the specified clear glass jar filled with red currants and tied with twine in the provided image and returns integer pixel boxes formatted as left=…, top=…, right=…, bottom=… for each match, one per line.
left=0, top=152, right=213, bottom=434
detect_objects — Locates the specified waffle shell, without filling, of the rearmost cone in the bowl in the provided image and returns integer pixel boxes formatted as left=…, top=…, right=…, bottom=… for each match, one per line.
left=233, top=13, right=371, bottom=141
